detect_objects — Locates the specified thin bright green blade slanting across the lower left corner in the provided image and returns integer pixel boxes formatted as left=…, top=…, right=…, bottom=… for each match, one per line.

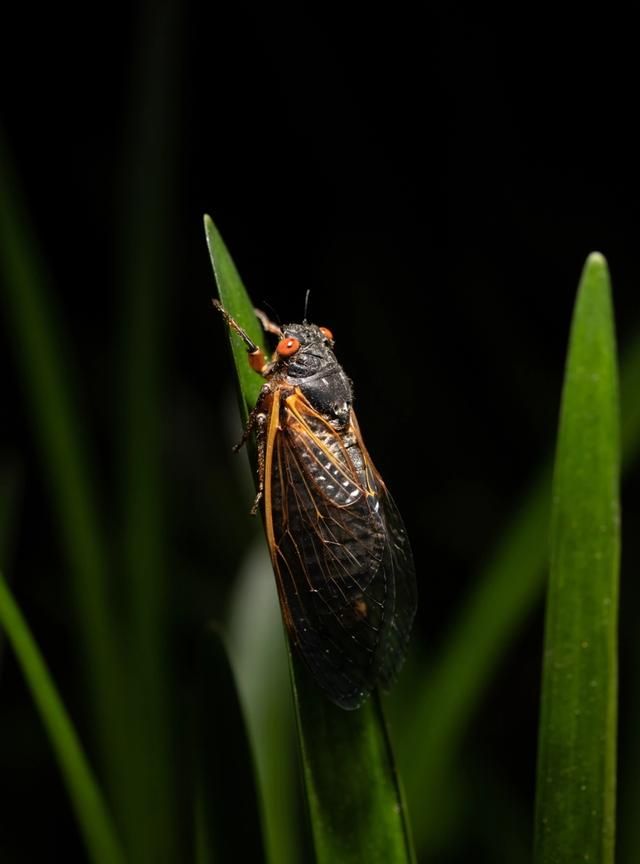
left=0, top=574, right=124, bottom=864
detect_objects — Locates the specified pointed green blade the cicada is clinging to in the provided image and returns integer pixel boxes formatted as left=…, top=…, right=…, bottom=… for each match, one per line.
left=205, top=217, right=413, bottom=864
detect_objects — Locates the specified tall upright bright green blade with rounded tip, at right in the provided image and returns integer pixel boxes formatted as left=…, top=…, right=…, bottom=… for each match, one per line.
left=535, top=253, right=620, bottom=864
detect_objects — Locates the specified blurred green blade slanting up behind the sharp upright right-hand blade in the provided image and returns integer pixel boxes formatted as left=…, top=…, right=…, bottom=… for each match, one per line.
left=396, top=314, right=640, bottom=860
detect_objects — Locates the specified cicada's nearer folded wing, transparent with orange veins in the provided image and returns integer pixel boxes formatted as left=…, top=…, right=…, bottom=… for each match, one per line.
left=266, top=395, right=395, bottom=708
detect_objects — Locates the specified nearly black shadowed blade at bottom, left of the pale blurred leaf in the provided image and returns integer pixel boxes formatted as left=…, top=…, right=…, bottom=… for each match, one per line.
left=196, top=628, right=265, bottom=864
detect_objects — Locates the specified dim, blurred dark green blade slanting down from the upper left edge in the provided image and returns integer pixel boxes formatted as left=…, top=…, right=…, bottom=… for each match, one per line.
left=0, top=137, right=126, bottom=786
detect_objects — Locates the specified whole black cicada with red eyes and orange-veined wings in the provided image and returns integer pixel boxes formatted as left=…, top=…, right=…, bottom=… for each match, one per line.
left=214, top=301, right=416, bottom=709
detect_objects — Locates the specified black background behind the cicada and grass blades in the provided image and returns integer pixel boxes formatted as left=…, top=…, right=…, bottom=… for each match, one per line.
left=0, top=3, right=640, bottom=861
